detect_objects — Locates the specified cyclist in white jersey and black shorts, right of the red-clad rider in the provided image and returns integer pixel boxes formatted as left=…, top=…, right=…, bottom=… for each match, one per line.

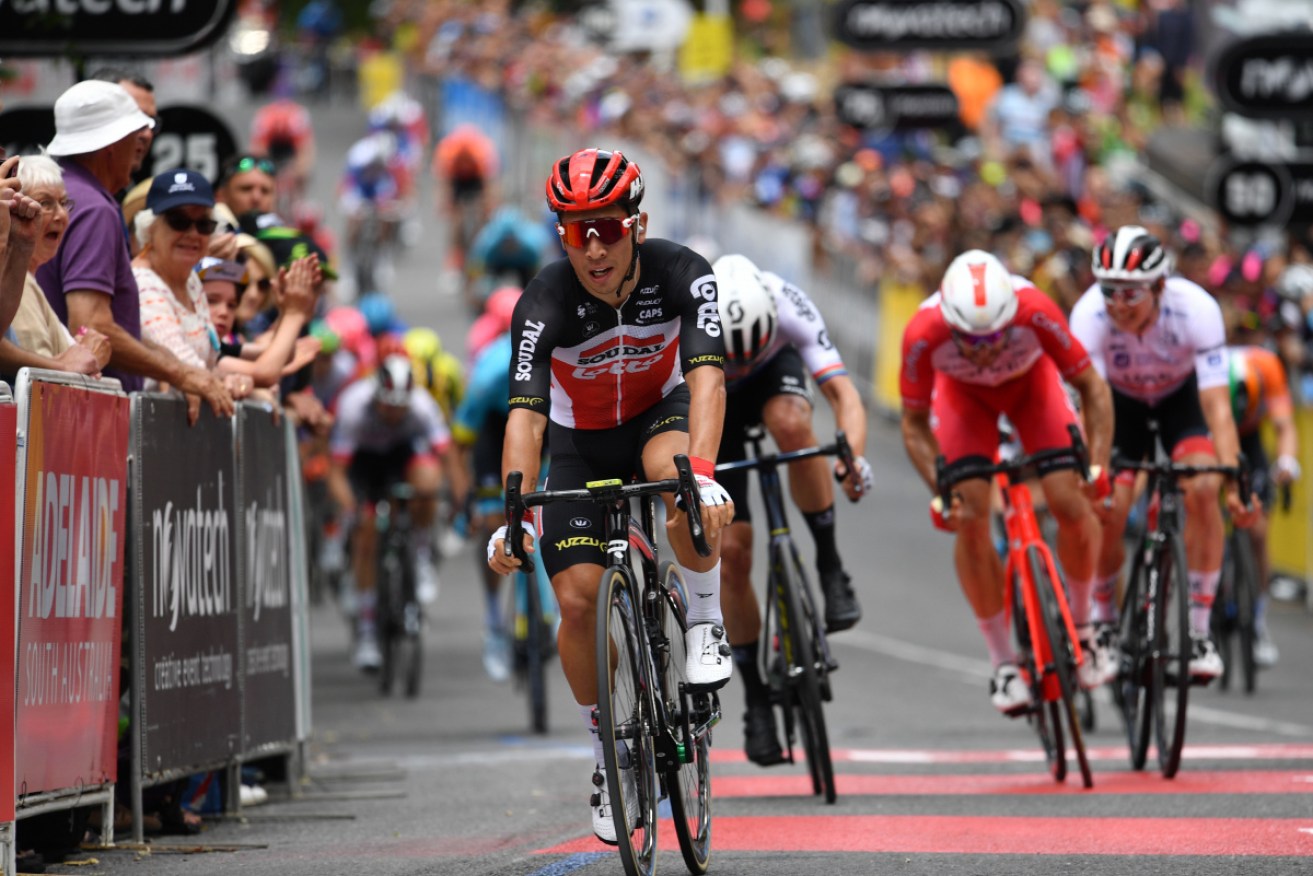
left=1071, top=226, right=1257, bottom=683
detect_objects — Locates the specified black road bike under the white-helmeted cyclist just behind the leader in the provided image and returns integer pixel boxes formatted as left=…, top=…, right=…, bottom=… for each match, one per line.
left=716, top=428, right=855, bottom=802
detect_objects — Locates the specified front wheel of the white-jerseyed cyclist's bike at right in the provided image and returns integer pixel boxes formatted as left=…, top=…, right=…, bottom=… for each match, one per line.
left=1154, top=532, right=1192, bottom=779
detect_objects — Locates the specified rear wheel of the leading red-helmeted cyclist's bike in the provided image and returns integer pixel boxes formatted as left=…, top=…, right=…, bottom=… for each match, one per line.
left=659, top=562, right=713, bottom=876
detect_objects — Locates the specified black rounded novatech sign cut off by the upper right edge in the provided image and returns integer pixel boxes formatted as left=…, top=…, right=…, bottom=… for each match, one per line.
left=1211, top=30, right=1313, bottom=120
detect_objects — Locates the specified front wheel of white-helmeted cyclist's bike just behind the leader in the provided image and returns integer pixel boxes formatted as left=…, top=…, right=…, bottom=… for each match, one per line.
left=771, top=548, right=838, bottom=804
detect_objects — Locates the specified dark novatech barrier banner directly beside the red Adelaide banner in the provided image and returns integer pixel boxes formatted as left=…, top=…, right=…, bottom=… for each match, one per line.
left=133, top=395, right=242, bottom=774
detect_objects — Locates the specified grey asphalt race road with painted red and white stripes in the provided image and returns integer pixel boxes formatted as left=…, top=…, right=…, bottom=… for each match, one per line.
left=64, top=94, right=1313, bottom=876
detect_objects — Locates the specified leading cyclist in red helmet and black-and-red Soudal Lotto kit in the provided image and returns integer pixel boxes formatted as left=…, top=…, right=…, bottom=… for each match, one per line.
left=488, top=150, right=734, bottom=843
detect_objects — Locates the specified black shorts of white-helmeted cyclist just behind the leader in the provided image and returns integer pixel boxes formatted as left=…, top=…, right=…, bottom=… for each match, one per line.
left=716, top=347, right=811, bottom=523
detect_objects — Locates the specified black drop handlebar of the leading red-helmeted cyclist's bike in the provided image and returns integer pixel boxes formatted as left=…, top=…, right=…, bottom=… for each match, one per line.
left=503, top=453, right=712, bottom=571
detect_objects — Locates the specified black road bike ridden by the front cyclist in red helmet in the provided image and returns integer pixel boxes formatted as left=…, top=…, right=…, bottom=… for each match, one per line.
left=506, top=454, right=721, bottom=876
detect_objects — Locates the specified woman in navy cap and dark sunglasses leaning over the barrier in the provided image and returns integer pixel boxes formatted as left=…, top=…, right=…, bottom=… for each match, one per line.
left=133, top=168, right=255, bottom=398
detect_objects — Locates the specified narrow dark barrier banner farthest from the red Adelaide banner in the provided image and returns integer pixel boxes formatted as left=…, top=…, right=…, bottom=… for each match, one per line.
left=238, top=403, right=297, bottom=751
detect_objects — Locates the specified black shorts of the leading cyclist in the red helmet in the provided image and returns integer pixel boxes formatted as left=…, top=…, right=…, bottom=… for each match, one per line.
left=538, top=383, right=689, bottom=577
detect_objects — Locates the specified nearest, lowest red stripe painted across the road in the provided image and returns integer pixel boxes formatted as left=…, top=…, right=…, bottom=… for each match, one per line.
left=540, top=814, right=1313, bottom=856
